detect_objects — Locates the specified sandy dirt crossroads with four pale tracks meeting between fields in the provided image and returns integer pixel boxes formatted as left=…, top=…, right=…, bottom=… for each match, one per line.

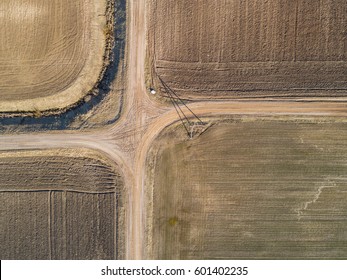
left=0, top=0, right=347, bottom=259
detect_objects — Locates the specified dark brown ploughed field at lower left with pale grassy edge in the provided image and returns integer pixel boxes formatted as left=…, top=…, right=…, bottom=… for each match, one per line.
left=0, top=149, right=125, bottom=259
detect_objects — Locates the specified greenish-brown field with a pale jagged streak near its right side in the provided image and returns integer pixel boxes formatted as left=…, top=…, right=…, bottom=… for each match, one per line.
left=145, top=117, right=347, bottom=259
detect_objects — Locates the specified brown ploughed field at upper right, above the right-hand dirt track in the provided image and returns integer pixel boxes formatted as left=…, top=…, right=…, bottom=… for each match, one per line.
left=147, top=0, right=347, bottom=100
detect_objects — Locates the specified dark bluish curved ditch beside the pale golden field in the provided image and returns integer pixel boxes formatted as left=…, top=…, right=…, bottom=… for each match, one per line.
left=0, top=0, right=127, bottom=132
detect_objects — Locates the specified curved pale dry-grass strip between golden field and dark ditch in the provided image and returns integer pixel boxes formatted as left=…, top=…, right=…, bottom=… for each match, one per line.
left=0, top=0, right=123, bottom=119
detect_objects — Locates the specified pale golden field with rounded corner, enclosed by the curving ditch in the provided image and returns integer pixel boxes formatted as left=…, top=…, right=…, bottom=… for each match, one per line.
left=0, top=0, right=107, bottom=112
